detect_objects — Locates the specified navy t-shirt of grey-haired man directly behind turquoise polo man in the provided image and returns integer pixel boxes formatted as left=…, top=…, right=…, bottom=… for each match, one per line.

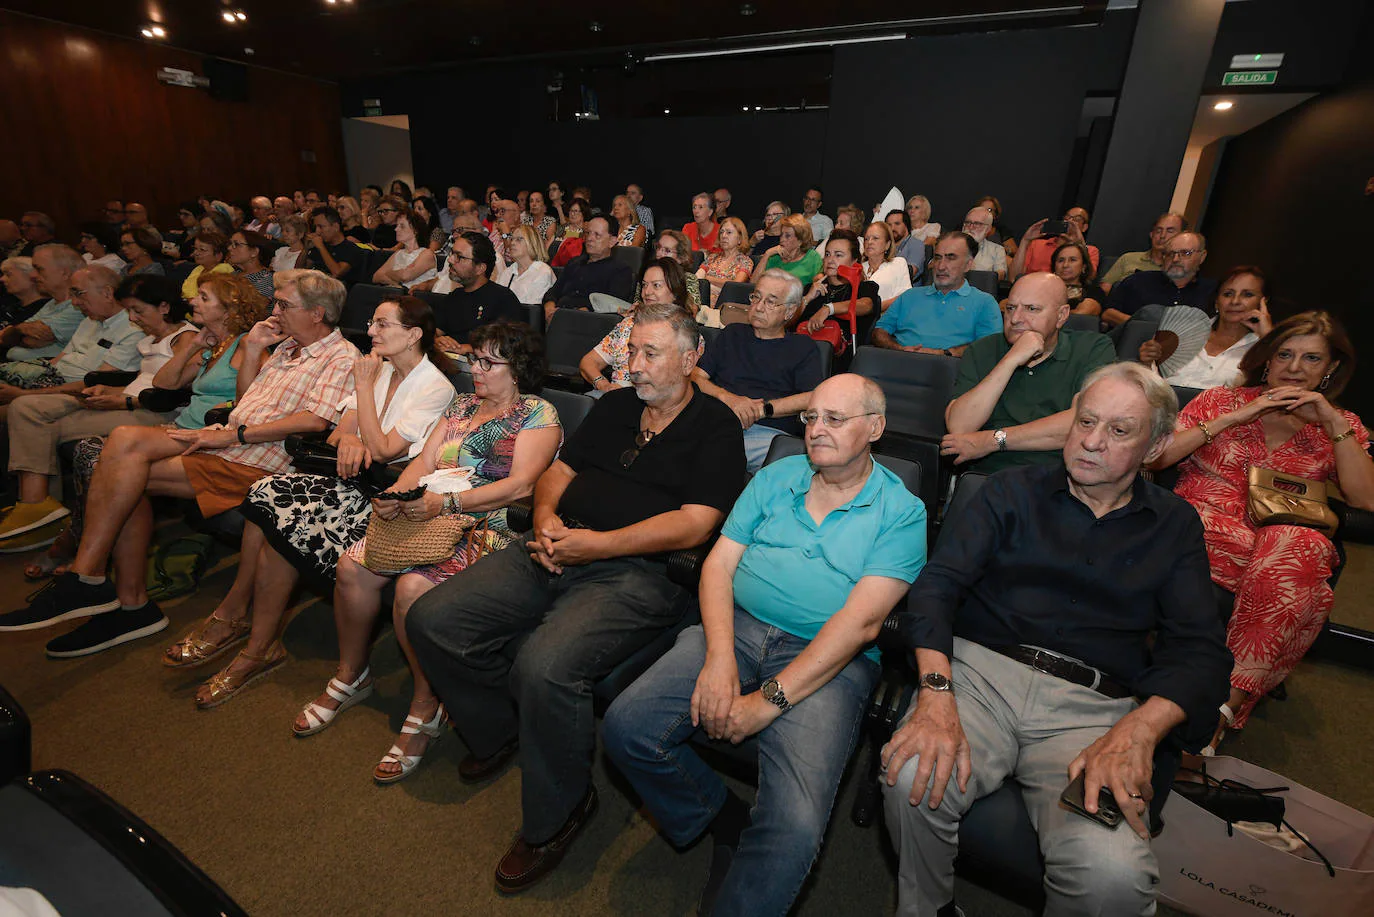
left=698, top=322, right=822, bottom=436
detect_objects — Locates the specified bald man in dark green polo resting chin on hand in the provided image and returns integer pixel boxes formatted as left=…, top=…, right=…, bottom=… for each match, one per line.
left=940, top=274, right=1116, bottom=474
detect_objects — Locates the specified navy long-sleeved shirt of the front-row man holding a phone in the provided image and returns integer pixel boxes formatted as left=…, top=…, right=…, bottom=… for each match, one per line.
left=900, top=466, right=1232, bottom=748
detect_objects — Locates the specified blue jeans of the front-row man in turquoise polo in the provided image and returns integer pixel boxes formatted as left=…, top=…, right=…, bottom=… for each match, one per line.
left=602, top=609, right=879, bottom=917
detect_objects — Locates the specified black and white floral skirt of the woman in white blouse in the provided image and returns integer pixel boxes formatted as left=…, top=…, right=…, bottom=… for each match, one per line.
left=240, top=474, right=372, bottom=588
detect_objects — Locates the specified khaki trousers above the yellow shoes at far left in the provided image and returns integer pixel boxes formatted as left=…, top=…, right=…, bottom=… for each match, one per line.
left=8, top=395, right=172, bottom=474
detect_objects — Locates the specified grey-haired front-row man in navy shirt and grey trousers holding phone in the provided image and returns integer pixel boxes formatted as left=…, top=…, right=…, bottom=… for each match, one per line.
left=882, top=363, right=1231, bottom=917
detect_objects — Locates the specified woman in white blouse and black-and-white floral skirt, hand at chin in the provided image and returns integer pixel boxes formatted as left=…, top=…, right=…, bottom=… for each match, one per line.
left=170, top=296, right=453, bottom=709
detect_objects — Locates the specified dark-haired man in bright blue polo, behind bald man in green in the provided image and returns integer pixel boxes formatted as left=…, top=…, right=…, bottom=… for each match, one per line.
left=872, top=231, right=1002, bottom=356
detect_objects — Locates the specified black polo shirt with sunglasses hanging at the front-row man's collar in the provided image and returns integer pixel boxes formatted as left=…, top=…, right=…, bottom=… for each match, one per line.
left=558, top=385, right=745, bottom=532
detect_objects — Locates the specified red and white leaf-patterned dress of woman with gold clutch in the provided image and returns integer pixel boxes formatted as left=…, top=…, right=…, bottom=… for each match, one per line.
left=1173, top=386, right=1370, bottom=729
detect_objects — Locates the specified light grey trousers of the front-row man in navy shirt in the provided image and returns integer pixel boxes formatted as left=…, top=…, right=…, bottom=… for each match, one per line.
left=883, top=638, right=1160, bottom=917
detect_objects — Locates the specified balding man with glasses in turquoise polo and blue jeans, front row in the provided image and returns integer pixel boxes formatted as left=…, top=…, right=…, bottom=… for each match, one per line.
left=602, top=374, right=926, bottom=914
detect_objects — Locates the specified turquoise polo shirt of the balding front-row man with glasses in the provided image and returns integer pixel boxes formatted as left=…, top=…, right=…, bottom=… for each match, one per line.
left=720, top=455, right=926, bottom=661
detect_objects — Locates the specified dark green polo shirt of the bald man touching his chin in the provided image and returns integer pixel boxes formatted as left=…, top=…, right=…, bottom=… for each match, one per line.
left=954, top=331, right=1116, bottom=474
